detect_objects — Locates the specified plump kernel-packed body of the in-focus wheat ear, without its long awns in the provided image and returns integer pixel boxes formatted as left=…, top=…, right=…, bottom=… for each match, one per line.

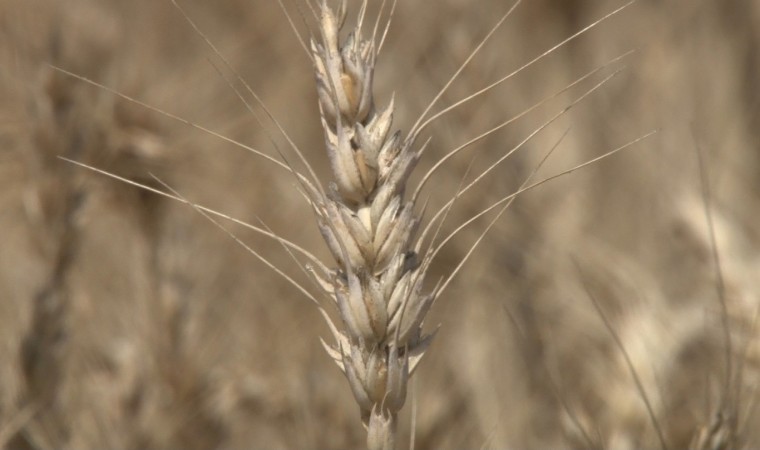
left=309, top=1, right=435, bottom=449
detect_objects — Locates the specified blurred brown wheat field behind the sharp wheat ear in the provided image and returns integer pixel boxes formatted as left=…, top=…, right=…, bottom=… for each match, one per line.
left=0, top=0, right=760, bottom=450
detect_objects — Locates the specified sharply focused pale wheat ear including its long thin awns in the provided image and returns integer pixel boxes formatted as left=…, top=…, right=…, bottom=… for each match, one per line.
left=46, top=0, right=660, bottom=448
